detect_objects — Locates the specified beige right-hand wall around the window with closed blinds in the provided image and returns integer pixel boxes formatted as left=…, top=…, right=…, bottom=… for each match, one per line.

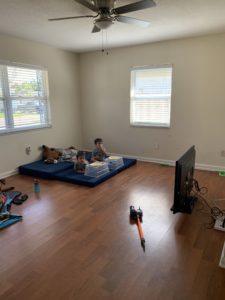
left=80, top=34, right=225, bottom=167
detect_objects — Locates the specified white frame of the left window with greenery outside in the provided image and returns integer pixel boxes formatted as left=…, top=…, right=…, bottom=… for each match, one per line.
left=0, top=60, right=52, bottom=135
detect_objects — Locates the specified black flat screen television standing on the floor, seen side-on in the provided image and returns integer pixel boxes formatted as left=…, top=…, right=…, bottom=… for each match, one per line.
left=171, top=146, right=197, bottom=214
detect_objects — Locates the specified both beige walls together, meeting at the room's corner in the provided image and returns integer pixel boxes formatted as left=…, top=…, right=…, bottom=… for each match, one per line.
left=0, top=34, right=225, bottom=175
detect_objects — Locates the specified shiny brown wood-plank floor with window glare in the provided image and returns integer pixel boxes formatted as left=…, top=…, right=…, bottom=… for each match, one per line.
left=0, top=162, right=225, bottom=300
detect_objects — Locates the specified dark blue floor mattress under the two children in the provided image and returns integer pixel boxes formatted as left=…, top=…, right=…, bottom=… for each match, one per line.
left=19, top=157, right=137, bottom=187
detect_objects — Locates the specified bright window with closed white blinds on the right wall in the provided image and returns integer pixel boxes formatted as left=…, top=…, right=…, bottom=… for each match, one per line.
left=130, top=66, right=172, bottom=127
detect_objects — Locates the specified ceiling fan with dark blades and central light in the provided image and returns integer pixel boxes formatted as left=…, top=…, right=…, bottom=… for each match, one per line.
left=48, top=0, right=156, bottom=33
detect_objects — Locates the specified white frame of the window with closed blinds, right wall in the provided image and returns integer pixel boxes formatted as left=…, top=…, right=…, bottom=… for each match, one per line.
left=130, top=64, right=173, bottom=128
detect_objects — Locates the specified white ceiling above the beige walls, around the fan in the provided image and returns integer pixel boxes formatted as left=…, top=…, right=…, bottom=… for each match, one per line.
left=0, top=0, right=225, bottom=52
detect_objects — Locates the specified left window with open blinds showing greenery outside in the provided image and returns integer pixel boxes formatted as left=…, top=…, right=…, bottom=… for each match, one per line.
left=0, top=63, right=50, bottom=134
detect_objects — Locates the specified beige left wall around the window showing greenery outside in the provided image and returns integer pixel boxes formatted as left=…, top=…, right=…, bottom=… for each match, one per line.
left=0, top=35, right=82, bottom=175
